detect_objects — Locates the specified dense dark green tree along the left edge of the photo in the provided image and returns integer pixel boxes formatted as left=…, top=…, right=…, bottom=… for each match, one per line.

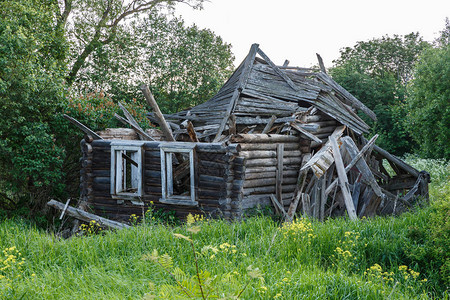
left=0, top=0, right=67, bottom=212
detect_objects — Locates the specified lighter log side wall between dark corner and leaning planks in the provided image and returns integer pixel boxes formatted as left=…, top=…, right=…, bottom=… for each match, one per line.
left=232, top=134, right=310, bottom=213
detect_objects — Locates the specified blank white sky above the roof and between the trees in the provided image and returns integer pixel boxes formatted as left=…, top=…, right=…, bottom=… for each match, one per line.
left=175, top=0, right=450, bottom=67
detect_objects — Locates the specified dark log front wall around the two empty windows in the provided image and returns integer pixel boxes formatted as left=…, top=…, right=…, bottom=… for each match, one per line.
left=80, top=140, right=243, bottom=221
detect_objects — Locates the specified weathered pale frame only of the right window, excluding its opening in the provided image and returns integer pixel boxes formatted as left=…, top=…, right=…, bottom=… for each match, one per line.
left=159, top=142, right=198, bottom=206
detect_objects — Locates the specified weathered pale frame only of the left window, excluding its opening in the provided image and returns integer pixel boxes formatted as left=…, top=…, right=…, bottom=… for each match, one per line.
left=110, top=141, right=144, bottom=205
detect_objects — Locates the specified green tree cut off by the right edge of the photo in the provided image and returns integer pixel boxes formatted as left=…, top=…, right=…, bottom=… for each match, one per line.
left=405, top=19, right=450, bottom=159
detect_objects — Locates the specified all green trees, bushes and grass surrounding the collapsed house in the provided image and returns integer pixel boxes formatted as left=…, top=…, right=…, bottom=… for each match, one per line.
left=0, top=0, right=450, bottom=299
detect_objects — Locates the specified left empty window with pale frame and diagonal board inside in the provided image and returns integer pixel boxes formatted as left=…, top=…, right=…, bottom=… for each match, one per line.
left=111, top=141, right=143, bottom=204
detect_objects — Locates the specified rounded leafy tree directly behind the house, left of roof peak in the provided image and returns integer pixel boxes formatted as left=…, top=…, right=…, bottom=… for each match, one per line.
left=74, top=10, right=233, bottom=112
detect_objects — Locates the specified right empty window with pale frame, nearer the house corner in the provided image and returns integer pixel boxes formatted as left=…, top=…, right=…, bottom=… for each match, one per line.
left=160, top=143, right=197, bottom=206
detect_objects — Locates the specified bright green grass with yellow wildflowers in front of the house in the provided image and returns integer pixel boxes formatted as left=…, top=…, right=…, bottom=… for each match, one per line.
left=0, top=157, right=450, bottom=299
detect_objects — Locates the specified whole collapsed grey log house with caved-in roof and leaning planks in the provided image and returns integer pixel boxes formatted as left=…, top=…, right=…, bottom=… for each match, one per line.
left=72, top=44, right=429, bottom=220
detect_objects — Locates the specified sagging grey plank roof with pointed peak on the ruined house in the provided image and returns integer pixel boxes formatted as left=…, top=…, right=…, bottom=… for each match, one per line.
left=162, top=44, right=376, bottom=141
